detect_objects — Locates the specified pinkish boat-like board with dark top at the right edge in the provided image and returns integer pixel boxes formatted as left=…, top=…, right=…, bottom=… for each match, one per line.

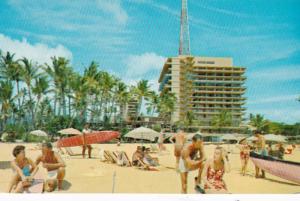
left=250, top=152, right=300, bottom=184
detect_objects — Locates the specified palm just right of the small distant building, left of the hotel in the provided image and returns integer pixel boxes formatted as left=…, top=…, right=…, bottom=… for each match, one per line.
left=134, top=80, right=151, bottom=120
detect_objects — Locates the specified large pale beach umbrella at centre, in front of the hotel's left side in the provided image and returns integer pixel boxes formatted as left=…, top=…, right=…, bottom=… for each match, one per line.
left=125, top=127, right=160, bottom=142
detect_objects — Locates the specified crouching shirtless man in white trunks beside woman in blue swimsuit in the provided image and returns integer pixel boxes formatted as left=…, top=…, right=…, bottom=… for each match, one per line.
left=35, top=142, right=66, bottom=192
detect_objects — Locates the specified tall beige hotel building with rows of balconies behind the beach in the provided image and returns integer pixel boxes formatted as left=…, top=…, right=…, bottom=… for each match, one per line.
left=159, top=55, right=246, bottom=133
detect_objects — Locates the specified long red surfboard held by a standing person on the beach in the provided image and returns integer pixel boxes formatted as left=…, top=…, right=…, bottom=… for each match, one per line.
left=57, top=131, right=120, bottom=148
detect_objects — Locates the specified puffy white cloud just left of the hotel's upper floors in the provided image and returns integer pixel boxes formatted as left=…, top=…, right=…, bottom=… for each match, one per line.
left=125, top=52, right=166, bottom=79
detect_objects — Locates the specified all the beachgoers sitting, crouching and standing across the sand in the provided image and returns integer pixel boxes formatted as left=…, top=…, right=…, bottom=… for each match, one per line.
left=8, top=125, right=296, bottom=194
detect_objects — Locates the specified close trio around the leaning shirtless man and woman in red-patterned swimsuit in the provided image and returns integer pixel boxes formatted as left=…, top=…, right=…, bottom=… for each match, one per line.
left=171, top=130, right=230, bottom=193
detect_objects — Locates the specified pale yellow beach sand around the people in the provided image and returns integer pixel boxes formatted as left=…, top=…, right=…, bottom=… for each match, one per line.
left=0, top=143, right=300, bottom=194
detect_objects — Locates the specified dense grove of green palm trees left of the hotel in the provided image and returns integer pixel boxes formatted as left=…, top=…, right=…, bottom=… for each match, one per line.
left=0, top=51, right=176, bottom=141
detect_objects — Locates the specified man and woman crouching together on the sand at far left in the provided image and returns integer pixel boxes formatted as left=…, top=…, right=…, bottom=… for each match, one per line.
left=8, top=143, right=66, bottom=193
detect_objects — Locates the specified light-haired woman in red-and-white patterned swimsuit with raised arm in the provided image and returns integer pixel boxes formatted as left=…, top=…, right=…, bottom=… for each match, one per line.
left=203, top=147, right=230, bottom=194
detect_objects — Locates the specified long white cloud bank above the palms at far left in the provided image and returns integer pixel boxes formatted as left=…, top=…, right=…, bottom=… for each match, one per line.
left=0, top=34, right=72, bottom=64
